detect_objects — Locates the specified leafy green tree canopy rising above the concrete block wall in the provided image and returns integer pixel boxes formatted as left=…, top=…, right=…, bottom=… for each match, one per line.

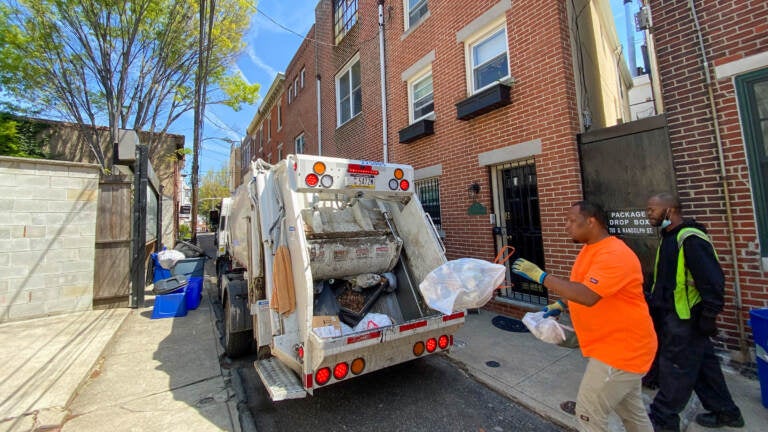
left=0, top=0, right=259, bottom=169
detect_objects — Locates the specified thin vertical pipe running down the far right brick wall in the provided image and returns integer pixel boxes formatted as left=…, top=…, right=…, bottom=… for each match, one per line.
left=688, top=0, right=749, bottom=361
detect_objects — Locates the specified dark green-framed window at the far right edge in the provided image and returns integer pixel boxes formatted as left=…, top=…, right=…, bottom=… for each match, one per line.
left=735, top=69, right=768, bottom=256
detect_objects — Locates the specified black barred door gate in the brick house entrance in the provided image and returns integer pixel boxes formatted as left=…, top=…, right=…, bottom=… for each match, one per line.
left=491, top=159, right=547, bottom=304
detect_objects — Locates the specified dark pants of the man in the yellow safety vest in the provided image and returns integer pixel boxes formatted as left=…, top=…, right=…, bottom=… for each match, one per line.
left=650, top=311, right=739, bottom=430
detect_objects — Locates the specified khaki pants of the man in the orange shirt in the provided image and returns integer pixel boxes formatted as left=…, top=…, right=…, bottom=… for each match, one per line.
left=576, top=358, right=653, bottom=432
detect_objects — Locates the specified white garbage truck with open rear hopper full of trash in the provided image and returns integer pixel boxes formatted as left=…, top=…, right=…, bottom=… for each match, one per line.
left=217, top=154, right=465, bottom=401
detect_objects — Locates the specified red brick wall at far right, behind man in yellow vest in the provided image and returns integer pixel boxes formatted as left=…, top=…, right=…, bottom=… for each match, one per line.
left=650, top=0, right=768, bottom=354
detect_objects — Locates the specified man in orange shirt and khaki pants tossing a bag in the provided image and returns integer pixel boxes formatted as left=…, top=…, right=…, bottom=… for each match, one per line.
left=512, top=201, right=657, bottom=432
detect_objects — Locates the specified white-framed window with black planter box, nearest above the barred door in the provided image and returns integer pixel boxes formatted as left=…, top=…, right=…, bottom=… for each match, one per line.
left=468, top=25, right=509, bottom=93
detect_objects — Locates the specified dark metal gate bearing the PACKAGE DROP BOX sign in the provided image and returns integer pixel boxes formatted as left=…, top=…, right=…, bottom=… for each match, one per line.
left=578, top=115, right=676, bottom=283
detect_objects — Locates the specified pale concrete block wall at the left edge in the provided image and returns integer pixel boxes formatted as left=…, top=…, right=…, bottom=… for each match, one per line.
left=0, top=156, right=99, bottom=322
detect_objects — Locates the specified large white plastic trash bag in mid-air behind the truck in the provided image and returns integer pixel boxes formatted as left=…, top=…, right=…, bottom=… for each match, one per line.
left=419, top=258, right=506, bottom=314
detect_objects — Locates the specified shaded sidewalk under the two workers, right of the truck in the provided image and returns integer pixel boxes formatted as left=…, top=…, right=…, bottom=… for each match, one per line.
left=450, top=309, right=768, bottom=432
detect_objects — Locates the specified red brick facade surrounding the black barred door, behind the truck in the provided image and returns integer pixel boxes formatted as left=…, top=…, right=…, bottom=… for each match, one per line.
left=386, top=0, right=582, bottom=276
